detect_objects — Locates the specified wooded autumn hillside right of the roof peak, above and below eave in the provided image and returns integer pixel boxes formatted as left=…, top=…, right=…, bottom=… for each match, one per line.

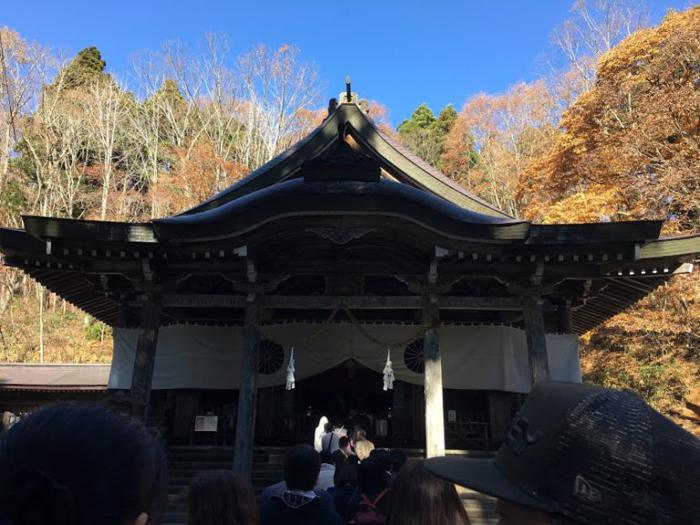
left=399, top=2, right=700, bottom=433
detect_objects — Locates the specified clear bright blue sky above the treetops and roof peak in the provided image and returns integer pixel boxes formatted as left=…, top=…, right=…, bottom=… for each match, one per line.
left=5, top=0, right=692, bottom=125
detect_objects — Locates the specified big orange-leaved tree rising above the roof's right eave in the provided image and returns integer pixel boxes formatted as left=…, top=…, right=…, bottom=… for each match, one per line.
left=518, top=7, right=700, bottom=231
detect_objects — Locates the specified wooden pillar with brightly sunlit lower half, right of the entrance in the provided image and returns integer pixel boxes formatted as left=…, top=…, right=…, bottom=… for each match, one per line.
left=423, top=293, right=445, bottom=458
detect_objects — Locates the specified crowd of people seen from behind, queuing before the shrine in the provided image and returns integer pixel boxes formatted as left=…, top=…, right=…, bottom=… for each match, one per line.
left=0, top=382, right=700, bottom=525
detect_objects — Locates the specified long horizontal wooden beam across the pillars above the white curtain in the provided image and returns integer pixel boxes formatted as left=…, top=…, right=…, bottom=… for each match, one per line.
left=163, top=294, right=540, bottom=311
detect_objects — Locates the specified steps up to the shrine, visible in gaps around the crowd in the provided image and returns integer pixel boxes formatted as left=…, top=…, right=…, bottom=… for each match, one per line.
left=164, top=447, right=498, bottom=525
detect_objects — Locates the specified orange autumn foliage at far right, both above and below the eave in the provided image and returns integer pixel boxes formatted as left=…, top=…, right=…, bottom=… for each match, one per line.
left=517, top=7, right=700, bottom=435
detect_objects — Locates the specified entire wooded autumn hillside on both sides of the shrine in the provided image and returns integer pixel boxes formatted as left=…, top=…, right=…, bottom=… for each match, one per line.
left=0, top=0, right=700, bottom=433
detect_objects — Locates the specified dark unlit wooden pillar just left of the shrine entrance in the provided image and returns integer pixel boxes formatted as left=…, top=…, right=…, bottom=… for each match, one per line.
left=233, top=294, right=260, bottom=476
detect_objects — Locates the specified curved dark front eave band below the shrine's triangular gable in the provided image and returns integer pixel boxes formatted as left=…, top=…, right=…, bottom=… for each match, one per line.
left=153, top=179, right=529, bottom=241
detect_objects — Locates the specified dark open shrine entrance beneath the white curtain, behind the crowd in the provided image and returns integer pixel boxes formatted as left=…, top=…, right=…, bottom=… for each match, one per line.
left=255, top=360, right=492, bottom=449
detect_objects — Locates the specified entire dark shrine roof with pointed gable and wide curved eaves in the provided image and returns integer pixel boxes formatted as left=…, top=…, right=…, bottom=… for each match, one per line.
left=0, top=95, right=700, bottom=333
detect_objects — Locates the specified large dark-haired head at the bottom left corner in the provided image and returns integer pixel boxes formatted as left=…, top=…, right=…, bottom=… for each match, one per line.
left=0, top=403, right=166, bottom=525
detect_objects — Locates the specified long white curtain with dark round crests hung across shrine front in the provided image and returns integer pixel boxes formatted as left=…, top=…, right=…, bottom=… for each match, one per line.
left=109, top=323, right=581, bottom=393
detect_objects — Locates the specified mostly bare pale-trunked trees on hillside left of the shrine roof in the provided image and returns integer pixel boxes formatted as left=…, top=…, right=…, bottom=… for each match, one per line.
left=0, top=36, right=324, bottom=361
